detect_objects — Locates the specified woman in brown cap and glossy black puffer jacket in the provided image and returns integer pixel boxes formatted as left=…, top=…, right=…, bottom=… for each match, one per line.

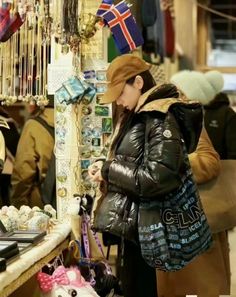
left=89, top=54, right=202, bottom=297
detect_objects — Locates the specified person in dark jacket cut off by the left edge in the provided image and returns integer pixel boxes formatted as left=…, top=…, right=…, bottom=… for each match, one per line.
left=0, top=107, right=20, bottom=205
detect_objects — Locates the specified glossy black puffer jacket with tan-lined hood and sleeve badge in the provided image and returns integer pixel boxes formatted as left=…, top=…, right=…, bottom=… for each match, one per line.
left=102, top=85, right=202, bottom=201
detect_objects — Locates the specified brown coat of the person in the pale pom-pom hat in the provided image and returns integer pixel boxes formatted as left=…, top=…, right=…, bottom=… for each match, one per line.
left=157, top=131, right=230, bottom=297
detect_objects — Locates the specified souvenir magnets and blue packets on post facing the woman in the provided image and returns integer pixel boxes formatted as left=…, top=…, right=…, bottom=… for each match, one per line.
left=55, top=65, right=112, bottom=209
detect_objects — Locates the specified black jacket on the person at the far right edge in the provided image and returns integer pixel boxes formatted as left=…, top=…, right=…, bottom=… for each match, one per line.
left=204, top=93, right=236, bottom=159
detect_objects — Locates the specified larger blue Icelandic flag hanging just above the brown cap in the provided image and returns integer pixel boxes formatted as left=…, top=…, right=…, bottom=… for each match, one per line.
left=102, top=1, right=144, bottom=54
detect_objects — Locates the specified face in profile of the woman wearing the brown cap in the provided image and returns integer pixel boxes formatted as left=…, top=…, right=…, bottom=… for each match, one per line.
left=116, top=77, right=143, bottom=110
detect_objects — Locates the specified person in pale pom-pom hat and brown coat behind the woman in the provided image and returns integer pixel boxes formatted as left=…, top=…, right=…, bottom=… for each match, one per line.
left=157, top=71, right=230, bottom=297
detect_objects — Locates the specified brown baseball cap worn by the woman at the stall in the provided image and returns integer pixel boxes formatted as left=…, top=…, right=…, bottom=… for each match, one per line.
left=100, top=54, right=150, bottom=104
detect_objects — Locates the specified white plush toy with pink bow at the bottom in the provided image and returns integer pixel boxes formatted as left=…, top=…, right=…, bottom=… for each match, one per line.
left=37, top=266, right=99, bottom=297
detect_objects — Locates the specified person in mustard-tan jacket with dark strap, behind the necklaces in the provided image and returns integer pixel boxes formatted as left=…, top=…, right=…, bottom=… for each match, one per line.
left=11, top=99, right=54, bottom=208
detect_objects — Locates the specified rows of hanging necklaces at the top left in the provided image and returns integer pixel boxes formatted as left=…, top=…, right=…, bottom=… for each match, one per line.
left=0, top=0, right=52, bottom=106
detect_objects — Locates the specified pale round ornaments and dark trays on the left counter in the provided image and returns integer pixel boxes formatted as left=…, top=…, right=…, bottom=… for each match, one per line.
left=0, top=205, right=57, bottom=265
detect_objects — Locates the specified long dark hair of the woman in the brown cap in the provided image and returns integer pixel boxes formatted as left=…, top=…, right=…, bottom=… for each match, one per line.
left=111, top=70, right=156, bottom=152
